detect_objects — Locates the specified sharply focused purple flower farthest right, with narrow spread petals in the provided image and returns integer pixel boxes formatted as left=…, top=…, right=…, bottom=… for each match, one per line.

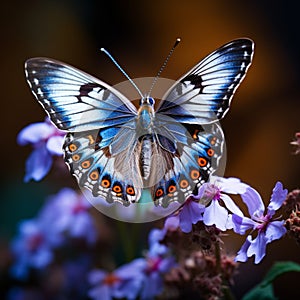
left=232, top=182, right=288, bottom=264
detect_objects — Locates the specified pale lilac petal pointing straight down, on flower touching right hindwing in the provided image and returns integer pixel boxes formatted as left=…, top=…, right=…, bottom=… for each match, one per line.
left=203, top=200, right=228, bottom=231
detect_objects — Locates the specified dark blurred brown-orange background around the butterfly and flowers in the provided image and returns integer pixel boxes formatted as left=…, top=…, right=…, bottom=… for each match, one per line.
left=0, top=0, right=300, bottom=298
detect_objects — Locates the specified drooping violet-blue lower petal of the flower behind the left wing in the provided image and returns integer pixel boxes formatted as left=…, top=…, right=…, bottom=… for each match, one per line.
left=24, top=145, right=52, bottom=182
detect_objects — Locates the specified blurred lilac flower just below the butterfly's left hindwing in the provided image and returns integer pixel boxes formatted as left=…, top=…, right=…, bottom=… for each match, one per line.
left=40, top=188, right=97, bottom=244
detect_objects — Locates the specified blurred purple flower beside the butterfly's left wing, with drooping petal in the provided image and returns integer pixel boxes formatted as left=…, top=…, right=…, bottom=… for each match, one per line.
left=17, top=119, right=65, bottom=182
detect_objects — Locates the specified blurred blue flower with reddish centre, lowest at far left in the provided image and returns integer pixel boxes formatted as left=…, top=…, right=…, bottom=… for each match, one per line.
left=11, top=219, right=53, bottom=279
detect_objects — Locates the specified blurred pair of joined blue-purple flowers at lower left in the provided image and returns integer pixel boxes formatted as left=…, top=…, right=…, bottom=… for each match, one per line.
left=12, top=188, right=96, bottom=279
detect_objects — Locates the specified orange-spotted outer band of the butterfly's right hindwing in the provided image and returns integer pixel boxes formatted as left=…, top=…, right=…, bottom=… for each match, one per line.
left=152, top=124, right=224, bottom=207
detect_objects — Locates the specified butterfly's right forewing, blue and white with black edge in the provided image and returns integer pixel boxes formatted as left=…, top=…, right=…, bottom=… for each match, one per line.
left=157, top=39, right=253, bottom=124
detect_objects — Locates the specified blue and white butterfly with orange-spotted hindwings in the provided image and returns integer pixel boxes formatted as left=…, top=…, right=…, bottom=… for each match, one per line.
left=25, top=38, right=254, bottom=207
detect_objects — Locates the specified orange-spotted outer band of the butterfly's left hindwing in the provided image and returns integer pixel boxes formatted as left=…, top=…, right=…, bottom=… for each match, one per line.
left=64, top=129, right=141, bottom=206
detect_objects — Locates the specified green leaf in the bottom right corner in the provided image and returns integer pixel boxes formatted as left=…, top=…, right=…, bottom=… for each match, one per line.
left=243, top=261, right=300, bottom=300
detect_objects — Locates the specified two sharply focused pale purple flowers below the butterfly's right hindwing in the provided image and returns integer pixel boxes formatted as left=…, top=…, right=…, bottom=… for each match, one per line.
left=165, top=178, right=287, bottom=263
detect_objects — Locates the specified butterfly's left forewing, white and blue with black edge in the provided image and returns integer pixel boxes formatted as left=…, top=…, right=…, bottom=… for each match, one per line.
left=25, top=58, right=136, bottom=132
